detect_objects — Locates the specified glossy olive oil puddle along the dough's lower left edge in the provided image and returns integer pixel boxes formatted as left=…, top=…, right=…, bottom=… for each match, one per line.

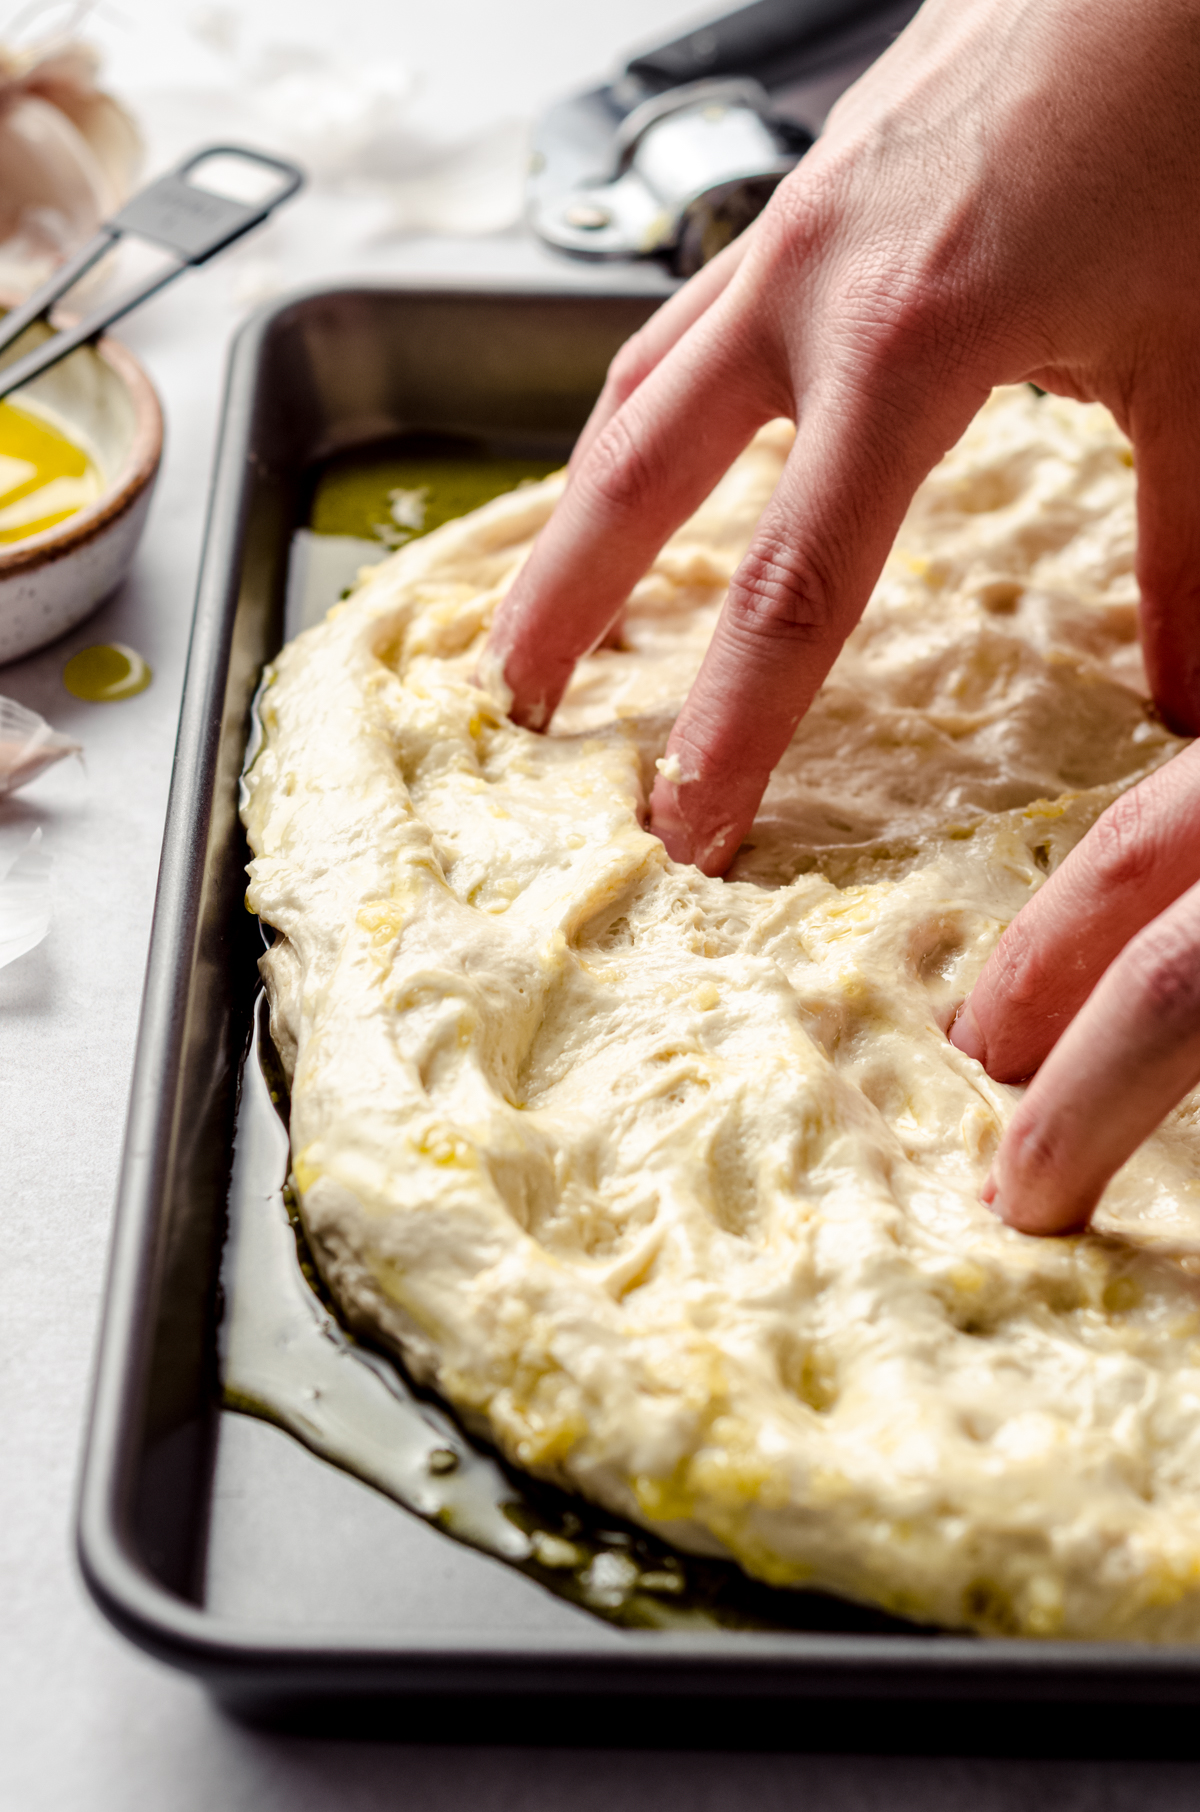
left=219, top=997, right=914, bottom=1631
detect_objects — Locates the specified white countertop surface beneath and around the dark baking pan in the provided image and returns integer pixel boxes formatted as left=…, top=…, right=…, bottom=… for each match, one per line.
left=0, top=0, right=1200, bottom=1812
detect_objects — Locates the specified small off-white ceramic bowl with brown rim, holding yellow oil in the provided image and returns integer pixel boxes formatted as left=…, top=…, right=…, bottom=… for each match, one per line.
left=0, top=309, right=163, bottom=663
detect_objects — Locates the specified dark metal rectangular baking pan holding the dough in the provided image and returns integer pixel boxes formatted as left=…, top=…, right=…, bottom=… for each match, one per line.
left=78, top=286, right=1200, bottom=1749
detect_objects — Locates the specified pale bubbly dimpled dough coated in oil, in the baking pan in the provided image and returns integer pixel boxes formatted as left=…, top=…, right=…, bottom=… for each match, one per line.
left=245, top=390, right=1200, bottom=1640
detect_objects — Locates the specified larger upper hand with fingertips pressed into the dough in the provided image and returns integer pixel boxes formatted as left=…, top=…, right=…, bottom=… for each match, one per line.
left=489, top=0, right=1200, bottom=873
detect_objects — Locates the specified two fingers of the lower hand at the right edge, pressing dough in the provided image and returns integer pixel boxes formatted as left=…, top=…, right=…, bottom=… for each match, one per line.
left=950, top=743, right=1200, bottom=1234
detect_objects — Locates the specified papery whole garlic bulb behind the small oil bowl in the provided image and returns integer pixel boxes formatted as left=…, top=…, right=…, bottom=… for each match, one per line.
left=0, top=40, right=141, bottom=292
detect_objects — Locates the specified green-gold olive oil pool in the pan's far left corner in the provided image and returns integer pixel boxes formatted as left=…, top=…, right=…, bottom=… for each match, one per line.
left=285, top=433, right=564, bottom=641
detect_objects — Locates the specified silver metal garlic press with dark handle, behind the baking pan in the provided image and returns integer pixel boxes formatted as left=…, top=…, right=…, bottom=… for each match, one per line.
left=529, top=0, right=917, bottom=277
